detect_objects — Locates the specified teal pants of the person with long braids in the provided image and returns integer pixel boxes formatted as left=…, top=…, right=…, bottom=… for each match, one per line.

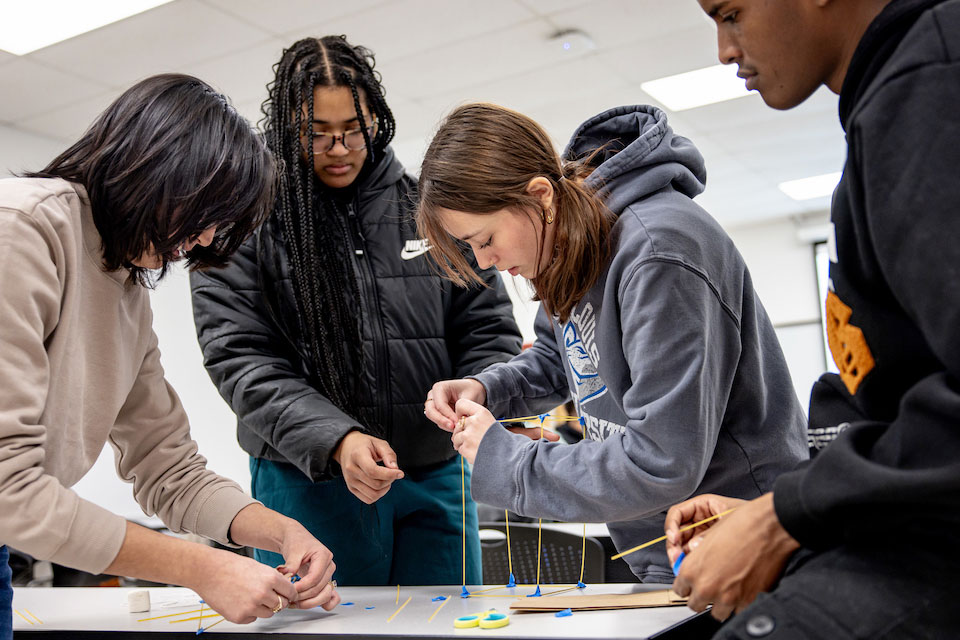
left=250, top=456, right=483, bottom=586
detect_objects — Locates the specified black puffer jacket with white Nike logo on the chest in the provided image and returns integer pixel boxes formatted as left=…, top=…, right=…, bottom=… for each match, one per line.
left=190, top=149, right=520, bottom=481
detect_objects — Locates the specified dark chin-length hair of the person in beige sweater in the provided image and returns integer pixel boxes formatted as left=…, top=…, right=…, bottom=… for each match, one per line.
left=24, top=73, right=275, bottom=286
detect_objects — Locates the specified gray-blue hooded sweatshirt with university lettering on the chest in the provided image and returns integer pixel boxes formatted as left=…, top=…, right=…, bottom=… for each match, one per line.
left=472, top=106, right=807, bottom=582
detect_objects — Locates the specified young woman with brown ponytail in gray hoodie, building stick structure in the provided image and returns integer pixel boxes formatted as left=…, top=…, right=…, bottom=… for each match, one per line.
left=418, top=104, right=807, bottom=582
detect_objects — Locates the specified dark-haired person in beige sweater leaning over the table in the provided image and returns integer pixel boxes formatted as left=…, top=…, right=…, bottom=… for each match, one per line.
left=0, top=74, right=339, bottom=638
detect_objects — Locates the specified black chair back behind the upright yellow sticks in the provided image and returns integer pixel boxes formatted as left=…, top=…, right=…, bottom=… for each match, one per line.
left=480, top=522, right=604, bottom=585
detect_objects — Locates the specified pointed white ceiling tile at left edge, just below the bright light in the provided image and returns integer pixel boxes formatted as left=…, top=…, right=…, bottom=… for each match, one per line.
left=0, top=57, right=106, bottom=122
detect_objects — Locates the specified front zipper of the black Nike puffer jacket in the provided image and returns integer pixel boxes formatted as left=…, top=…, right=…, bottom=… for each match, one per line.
left=347, top=203, right=393, bottom=441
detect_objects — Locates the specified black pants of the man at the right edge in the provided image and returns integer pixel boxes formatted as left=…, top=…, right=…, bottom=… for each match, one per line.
left=713, top=542, right=960, bottom=640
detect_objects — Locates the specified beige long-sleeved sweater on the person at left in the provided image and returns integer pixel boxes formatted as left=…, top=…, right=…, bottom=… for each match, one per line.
left=0, top=178, right=254, bottom=573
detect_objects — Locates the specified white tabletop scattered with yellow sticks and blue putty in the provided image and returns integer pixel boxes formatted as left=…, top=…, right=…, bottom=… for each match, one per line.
left=13, top=584, right=693, bottom=640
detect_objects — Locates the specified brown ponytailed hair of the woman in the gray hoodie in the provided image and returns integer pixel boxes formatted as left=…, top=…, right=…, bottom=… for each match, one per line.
left=417, top=103, right=614, bottom=322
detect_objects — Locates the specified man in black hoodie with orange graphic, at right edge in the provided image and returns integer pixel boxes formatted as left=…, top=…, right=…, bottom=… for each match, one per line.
left=666, top=0, right=960, bottom=638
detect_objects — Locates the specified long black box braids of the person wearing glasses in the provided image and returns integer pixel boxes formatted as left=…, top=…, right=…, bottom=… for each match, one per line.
left=261, top=36, right=396, bottom=426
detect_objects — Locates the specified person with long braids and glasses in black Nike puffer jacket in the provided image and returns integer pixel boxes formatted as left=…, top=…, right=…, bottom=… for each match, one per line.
left=191, top=36, right=520, bottom=585
